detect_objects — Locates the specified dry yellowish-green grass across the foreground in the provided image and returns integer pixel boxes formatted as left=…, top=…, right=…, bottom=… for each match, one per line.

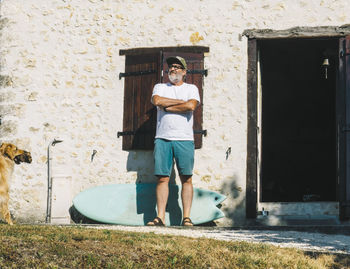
left=0, top=224, right=350, bottom=269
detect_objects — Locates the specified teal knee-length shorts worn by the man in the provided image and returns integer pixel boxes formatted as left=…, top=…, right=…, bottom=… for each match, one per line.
left=153, top=138, right=194, bottom=177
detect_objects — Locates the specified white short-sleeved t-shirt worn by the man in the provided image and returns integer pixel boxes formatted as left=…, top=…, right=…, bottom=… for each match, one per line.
left=152, top=83, right=200, bottom=140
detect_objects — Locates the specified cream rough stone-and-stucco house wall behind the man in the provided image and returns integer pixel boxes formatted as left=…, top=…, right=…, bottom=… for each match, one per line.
left=0, top=0, right=350, bottom=225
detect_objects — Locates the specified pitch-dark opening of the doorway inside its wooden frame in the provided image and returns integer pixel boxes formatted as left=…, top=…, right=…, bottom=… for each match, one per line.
left=258, top=38, right=339, bottom=202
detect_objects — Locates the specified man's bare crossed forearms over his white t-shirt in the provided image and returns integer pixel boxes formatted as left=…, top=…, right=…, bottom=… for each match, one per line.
left=152, top=95, right=198, bottom=113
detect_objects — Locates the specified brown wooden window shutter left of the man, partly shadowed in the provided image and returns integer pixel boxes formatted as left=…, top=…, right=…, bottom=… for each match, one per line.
left=123, top=53, right=160, bottom=150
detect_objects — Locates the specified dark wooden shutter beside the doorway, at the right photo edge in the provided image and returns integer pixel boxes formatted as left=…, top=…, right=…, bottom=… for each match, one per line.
left=337, top=36, right=350, bottom=220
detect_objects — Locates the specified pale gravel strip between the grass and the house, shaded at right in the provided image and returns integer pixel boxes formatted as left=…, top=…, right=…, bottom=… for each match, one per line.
left=84, top=225, right=350, bottom=254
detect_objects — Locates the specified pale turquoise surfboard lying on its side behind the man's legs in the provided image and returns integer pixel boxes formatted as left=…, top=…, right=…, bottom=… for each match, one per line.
left=73, top=183, right=226, bottom=225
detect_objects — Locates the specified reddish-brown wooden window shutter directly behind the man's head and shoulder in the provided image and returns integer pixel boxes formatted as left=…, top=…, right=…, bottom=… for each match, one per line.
left=163, top=52, right=204, bottom=149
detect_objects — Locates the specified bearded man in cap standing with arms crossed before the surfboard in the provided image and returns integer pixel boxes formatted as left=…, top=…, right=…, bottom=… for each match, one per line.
left=147, top=56, right=200, bottom=226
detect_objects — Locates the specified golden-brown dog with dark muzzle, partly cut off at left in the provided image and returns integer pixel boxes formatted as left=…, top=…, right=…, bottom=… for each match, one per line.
left=0, top=143, right=32, bottom=225
